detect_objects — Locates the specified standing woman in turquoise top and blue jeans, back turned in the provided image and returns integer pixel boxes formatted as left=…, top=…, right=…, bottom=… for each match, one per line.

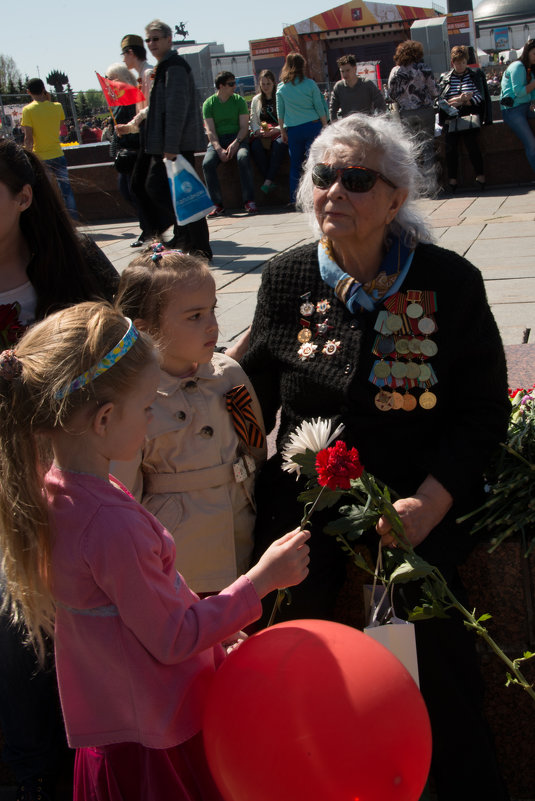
left=277, top=53, right=327, bottom=203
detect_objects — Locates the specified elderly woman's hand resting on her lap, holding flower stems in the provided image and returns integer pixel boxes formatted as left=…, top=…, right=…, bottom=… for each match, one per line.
left=376, top=475, right=453, bottom=548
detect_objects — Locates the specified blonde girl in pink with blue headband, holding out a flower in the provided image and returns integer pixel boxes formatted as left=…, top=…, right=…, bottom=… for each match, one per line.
left=0, top=303, right=308, bottom=801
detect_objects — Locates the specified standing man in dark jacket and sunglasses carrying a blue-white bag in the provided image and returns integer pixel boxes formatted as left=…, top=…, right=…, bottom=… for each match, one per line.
left=136, top=19, right=212, bottom=259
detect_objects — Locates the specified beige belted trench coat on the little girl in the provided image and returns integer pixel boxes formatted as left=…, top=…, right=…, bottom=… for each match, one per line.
left=111, top=353, right=266, bottom=592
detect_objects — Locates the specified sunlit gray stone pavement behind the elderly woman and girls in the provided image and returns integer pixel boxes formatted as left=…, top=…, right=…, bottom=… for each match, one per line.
left=79, top=185, right=535, bottom=352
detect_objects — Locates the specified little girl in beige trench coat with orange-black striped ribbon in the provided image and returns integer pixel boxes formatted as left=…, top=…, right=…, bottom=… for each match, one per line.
left=113, top=245, right=265, bottom=593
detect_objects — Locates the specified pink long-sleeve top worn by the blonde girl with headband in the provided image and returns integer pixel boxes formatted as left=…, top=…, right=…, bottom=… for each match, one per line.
left=46, top=467, right=261, bottom=748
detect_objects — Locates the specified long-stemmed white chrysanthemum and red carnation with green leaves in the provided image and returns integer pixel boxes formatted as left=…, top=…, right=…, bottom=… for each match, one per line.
left=276, top=418, right=535, bottom=701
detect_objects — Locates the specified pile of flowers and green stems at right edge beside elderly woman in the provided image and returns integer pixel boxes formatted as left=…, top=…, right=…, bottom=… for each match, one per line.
left=461, top=386, right=535, bottom=556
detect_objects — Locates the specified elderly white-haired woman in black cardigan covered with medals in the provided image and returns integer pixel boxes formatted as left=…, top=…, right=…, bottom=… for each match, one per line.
left=242, top=114, right=509, bottom=801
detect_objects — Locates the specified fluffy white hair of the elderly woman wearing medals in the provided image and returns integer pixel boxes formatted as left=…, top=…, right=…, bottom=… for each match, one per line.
left=297, top=114, right=436, bottom=247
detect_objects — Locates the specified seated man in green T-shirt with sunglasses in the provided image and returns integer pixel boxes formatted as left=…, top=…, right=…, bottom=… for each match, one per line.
left=202, top=70, right=257, bottom=217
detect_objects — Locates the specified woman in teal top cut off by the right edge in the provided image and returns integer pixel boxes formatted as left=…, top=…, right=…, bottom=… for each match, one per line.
left=500, top=39, right=535, bottom=170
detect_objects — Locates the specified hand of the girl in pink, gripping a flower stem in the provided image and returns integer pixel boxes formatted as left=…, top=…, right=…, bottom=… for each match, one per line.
left=246, top=529, right=310, bottom=598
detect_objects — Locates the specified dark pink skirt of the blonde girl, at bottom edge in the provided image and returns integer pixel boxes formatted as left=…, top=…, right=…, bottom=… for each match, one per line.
left=73, top=732, right=223, bottom=801
